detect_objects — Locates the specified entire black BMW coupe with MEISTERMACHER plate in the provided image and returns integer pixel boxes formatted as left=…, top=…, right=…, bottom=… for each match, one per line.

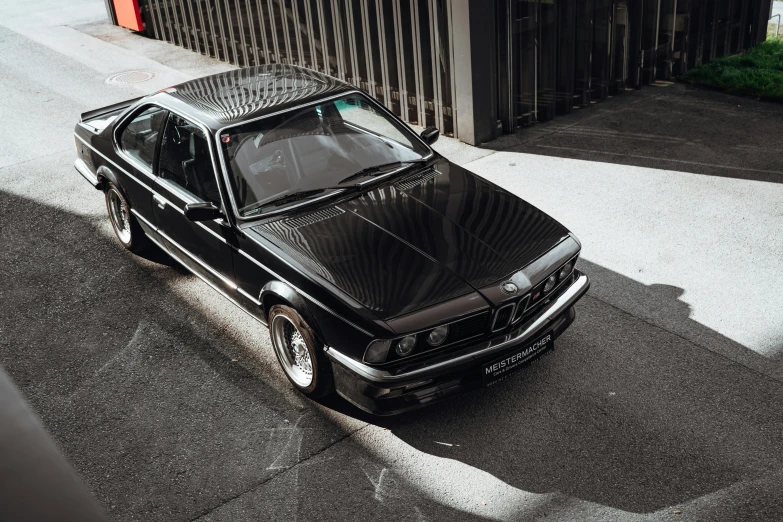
left=74, top=65, right=589, bottom=414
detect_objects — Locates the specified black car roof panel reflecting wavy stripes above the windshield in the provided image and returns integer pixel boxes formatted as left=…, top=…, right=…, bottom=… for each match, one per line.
left=163, top=64, right=356, bottom=131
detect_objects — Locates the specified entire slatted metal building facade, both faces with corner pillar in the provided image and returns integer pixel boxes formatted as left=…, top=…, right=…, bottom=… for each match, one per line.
left=125, top=0, right=770, bottom=144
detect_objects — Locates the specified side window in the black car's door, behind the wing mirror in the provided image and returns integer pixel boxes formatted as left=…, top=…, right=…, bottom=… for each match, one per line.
left=158, top=113, right=221, bottom=207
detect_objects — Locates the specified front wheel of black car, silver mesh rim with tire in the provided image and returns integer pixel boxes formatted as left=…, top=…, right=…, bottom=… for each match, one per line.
left=268, top=305, right=334, bottom=399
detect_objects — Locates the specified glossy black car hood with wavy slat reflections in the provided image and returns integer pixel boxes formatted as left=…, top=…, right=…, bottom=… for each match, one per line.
left=252, top=156, right=568, bottom=320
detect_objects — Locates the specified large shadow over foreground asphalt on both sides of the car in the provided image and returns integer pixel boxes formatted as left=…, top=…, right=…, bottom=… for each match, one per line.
left=0, top=192, right=783, bottom=520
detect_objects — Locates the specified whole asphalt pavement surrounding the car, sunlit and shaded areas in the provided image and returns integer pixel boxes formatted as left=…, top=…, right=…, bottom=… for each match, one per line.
left=0, top=0, right=783, bottom=522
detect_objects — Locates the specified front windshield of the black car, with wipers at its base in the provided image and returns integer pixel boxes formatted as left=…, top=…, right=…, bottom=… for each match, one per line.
left=220, top=94, right=430, bottom=217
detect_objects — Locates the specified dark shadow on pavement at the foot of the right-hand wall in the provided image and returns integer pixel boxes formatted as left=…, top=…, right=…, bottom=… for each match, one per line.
left=482, top=84, right=783, bottom=183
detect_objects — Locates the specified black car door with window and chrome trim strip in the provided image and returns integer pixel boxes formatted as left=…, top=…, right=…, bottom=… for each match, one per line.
left=152, top=112, right=236, bottom=291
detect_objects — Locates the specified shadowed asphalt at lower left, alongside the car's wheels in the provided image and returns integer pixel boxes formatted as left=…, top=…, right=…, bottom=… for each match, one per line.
left=0, top=190, right=490, bottom=522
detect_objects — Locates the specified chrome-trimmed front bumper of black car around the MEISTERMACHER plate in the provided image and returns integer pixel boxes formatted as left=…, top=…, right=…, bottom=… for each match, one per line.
left=326, top=271, right=590, bottom=415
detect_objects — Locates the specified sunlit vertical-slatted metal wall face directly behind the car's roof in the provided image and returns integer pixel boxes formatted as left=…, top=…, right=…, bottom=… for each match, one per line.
left=139, top=0, right=455, bottom=134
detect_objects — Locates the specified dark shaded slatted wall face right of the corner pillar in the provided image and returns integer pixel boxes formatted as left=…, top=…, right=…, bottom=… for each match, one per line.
left=494, top=0, right=770, bottom=132
